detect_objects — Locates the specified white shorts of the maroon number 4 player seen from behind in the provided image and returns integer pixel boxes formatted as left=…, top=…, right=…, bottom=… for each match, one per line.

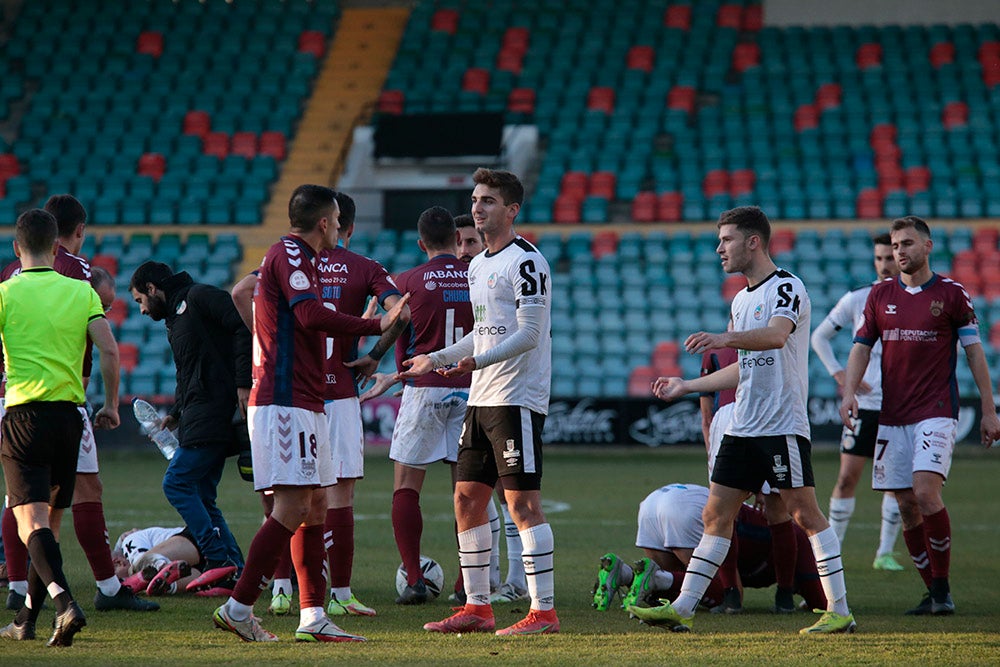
left=389, top=386, right=469, bottom=466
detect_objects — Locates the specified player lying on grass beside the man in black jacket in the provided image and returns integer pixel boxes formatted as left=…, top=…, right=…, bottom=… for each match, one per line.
left=111, top=526, right=235, bottom=597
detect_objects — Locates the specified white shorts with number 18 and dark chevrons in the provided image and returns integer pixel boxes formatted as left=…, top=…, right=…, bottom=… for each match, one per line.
left=247, top=405, right=337, bottom=491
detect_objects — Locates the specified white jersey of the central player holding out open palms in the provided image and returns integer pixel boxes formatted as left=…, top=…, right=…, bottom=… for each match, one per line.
left=469, top=237, right=552, bottom=414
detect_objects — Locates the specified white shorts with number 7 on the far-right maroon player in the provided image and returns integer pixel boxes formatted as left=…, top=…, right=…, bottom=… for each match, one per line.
left=872, top=417, right=958, bottom=491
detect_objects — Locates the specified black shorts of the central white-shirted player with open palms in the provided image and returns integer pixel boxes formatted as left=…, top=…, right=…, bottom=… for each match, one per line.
left=457, top=405, right=545, bottom=491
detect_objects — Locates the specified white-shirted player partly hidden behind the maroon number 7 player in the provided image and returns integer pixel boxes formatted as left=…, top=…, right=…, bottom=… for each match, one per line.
left=812, top=234, right=903, bottom=572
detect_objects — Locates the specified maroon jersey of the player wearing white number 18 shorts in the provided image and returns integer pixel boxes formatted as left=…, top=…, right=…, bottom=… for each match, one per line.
left=250, top=235, right=326, bottom=412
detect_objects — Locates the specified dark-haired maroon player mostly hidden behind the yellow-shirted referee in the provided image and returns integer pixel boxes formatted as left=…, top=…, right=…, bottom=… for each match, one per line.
left=0, top=195, right=160, bottom=611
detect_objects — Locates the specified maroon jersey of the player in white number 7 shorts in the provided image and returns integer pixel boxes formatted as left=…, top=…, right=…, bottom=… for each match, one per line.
left=854, top=273, right=979, bottom=426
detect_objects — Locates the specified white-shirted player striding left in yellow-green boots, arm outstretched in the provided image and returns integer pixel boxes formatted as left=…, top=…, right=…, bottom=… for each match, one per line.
left=629, top=206, right=856, bottom=634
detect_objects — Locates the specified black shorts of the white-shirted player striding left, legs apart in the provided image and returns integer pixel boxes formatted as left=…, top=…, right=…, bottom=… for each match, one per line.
left=712, top=435, right=815, bottom=492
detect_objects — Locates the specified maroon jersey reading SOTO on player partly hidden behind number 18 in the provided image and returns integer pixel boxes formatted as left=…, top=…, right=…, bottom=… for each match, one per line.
left=316, top=247, right=399, bottom=401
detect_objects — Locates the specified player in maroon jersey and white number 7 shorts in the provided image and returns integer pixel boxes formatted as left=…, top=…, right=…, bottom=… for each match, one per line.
left=840, top=215, right=1000, bottom=616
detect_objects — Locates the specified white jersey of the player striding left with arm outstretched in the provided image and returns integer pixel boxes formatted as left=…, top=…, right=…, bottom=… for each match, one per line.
left=726, top=269, right=811, bottom=439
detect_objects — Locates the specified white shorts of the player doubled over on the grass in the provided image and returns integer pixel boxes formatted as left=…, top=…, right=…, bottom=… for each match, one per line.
left=635, top=484, right=708, bottom=551
